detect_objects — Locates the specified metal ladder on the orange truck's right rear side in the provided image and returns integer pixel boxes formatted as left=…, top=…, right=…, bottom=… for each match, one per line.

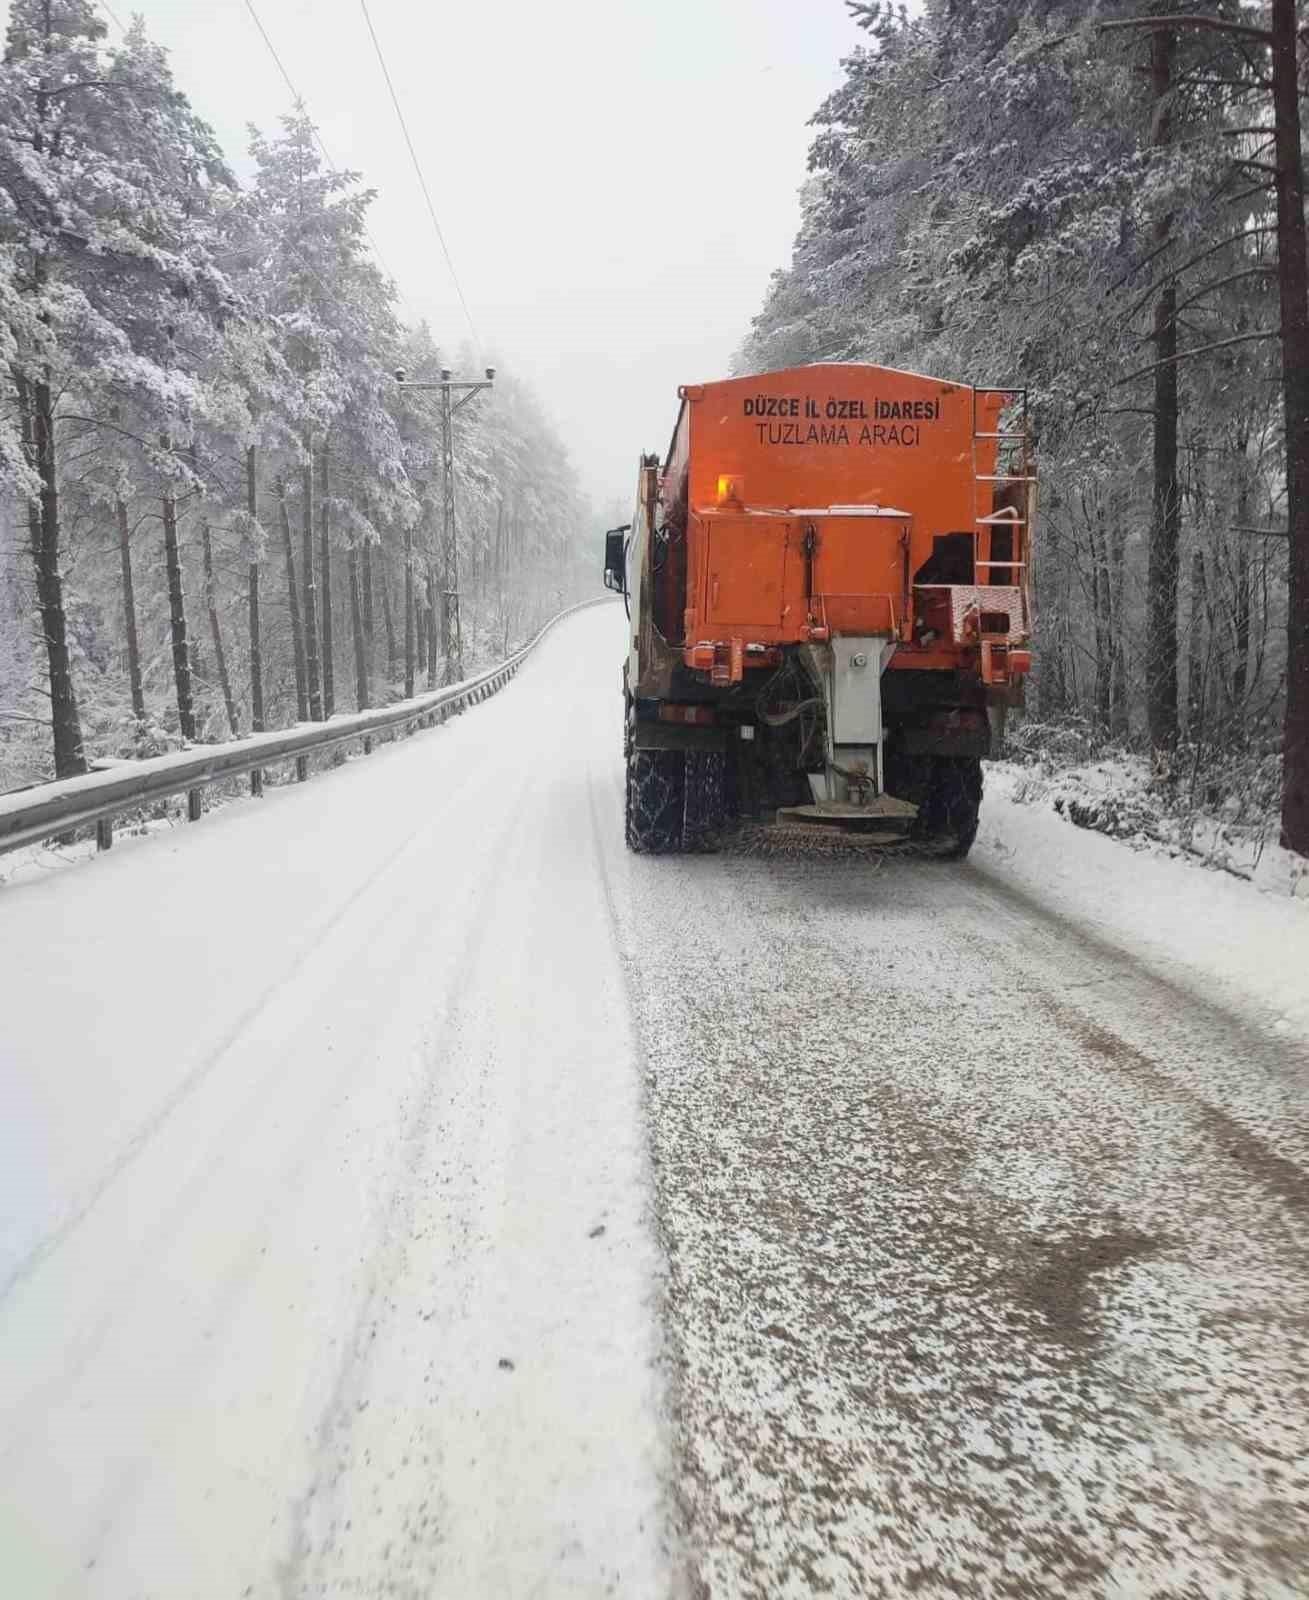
left=973, top=386, right=1035, bottom=683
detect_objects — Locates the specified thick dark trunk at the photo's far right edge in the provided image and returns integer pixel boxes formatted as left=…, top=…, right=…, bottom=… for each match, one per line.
left=1272, top=0, right=1309, bottom=856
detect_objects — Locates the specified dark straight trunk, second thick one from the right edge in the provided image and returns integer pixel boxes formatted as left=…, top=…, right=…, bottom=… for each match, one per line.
left=1146, top=27, right=1181, bottom=749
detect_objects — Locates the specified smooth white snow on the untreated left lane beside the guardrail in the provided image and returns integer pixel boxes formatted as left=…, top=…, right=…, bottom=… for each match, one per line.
left=0, top=601, right=667, bottom=1600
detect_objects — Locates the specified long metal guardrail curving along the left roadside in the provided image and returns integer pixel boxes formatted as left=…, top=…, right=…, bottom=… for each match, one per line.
left=0, top=595, right=611, bottom=853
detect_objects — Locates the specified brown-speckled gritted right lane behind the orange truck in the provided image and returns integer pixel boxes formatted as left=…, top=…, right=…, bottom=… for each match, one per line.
left=595, top=768, right=1309, bottom=1600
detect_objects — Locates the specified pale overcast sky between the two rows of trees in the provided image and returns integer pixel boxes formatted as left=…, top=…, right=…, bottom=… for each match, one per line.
left=63, top=0, right=861, bottom=509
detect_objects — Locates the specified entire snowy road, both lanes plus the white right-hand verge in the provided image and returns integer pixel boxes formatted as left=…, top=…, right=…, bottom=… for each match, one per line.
left=0, top=608, right=1309, bottom=1600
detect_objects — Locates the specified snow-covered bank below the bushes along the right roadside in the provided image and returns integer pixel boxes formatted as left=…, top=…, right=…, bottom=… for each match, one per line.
left=971, top=763, right=1309, bottom=1037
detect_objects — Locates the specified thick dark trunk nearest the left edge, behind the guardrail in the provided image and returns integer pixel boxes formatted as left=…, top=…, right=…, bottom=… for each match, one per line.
left=14, top=373, right=86, bottom=778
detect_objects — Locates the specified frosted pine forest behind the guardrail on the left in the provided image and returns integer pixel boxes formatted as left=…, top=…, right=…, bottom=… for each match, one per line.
left=0, top=0, right=597, bottom=789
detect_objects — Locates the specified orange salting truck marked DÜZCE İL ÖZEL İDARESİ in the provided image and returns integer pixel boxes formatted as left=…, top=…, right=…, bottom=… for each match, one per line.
left=605, top=363, right=1035, bottom=858
